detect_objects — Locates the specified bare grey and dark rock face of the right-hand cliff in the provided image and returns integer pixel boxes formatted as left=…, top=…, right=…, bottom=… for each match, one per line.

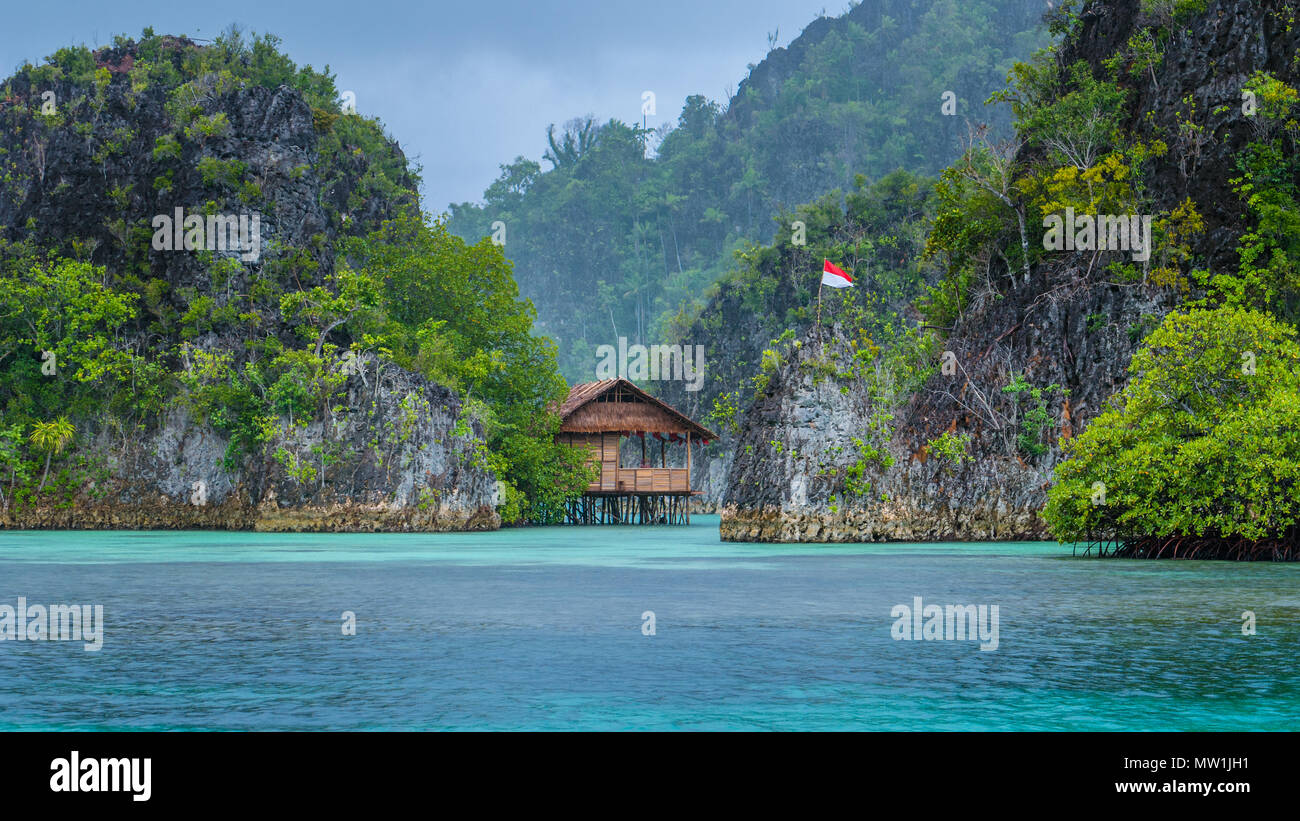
left=722, top=0, right=1300, bottom=542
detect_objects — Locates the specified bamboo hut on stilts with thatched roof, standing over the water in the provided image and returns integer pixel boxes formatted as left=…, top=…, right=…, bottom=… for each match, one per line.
left=558, top=379, right=718, bottom=525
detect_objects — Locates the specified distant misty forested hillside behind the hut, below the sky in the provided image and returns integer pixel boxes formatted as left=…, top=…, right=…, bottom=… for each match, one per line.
left=449, top=0, right=1044, bottom=381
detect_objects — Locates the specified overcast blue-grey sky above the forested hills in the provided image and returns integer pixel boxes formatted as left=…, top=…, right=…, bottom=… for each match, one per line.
left=0, top=0, right=848, bottom=212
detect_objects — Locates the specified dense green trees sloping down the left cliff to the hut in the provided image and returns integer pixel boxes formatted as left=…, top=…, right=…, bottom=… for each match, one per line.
left=346, top=214, right=588, bottom=522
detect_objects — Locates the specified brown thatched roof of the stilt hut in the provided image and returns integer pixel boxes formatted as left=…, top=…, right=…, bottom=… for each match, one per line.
left=560, top=379, right=718, bottom=442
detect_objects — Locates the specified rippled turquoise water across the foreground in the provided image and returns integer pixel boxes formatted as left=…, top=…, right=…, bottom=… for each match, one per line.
left=0, top=517, right=1300, bottom=730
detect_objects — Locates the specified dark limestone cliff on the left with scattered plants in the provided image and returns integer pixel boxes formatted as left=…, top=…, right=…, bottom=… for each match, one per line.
left=0, top=34, right=501, bottom=530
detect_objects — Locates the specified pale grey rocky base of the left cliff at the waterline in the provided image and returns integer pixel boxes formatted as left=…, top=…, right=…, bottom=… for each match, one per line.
left=0, top=357, right=501, bottom=533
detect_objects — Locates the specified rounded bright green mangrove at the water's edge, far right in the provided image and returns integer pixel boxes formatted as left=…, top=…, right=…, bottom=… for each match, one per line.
left=1044, top=307, right=1300, bottom=548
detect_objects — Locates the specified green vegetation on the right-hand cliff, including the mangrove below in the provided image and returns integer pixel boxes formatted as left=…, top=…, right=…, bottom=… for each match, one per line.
left=832, top=0, right=1300, bottom=557
